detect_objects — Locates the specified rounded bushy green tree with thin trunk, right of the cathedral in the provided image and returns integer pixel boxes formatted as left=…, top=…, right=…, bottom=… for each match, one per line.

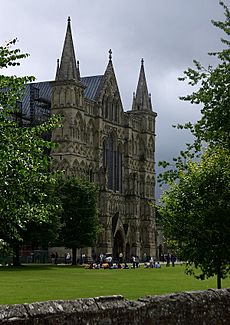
left=160, top=147, right=230, bottom=288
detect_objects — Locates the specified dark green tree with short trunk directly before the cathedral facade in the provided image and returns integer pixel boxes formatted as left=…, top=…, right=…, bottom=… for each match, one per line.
left=58, top=177, right=99, bottom=265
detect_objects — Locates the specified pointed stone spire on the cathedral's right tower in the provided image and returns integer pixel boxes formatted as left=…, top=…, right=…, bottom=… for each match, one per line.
left=132, top=59, right=152, bottom=111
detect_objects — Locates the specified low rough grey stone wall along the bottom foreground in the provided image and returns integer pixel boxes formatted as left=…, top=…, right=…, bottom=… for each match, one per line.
left=0, top=289, right=230, bottom=325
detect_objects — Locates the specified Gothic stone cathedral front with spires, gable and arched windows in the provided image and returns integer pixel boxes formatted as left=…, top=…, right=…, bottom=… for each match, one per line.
left=51, top=19, right=157, bottom=259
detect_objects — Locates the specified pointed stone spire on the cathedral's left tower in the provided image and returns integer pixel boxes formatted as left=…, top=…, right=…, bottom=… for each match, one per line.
left=56, top=17, right=80, bottom=81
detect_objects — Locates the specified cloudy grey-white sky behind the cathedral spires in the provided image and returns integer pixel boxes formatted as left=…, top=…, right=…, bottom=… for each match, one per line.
left=0, top=0, right=226, bottom=197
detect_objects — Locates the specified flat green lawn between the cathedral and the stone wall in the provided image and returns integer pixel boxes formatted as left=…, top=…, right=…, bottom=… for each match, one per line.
left=0, top=265, right=230, bottom=304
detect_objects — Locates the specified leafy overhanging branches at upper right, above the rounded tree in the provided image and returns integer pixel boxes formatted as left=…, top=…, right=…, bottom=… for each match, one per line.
left=179, top=1, right=230, bottom=148
